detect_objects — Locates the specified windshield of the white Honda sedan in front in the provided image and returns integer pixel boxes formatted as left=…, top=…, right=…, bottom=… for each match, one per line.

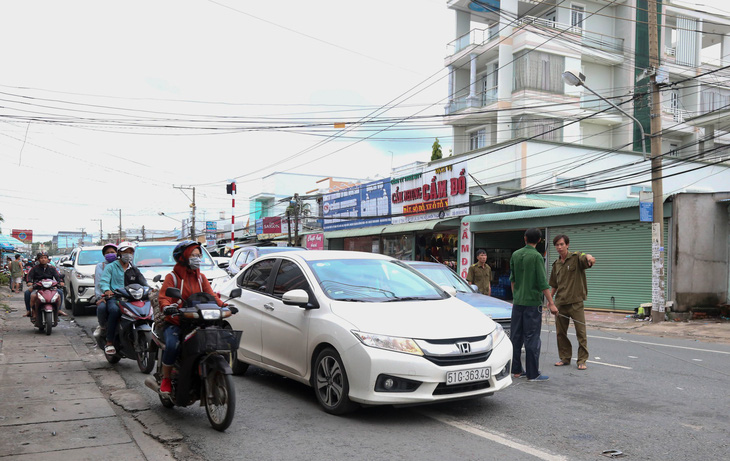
left=309, top=259, right=448, bottom=302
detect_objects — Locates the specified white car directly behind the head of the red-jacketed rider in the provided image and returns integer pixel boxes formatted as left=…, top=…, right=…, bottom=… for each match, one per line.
left=134, top=241, right=229, bottom=290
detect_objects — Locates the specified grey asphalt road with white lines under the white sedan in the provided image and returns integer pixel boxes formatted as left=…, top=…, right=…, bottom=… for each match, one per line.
left=72, top=310, right=730, bottom=461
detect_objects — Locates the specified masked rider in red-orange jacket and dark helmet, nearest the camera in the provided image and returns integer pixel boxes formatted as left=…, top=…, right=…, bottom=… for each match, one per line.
left=159, top=240, right=227, bottom=393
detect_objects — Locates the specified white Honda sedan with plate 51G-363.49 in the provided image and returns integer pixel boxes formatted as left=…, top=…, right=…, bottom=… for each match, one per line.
left=221, top=251, right=512, bottom=414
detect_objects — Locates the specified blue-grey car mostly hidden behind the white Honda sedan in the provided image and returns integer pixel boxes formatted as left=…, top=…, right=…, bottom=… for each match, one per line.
left=405, top=261, right=512, bottom=336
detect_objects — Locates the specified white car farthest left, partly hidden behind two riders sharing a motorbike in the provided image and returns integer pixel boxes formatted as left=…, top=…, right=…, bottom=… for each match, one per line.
left=59, top=246, right=104, bottom=315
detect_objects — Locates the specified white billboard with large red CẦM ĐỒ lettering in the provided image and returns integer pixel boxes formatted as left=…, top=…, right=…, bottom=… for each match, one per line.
left=390, top=161, right=469, bottom=224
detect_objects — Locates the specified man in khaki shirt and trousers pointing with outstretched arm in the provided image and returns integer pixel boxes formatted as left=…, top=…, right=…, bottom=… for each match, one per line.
left=549, top=234, right=596, bottom=370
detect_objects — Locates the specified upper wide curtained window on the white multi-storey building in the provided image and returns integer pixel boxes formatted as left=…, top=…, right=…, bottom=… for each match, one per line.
left=514, top=50, right=565, bottom=94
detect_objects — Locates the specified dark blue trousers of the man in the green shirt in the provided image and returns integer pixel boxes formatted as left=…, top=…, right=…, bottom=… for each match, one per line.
left=510, top=304, right=542, bottom=379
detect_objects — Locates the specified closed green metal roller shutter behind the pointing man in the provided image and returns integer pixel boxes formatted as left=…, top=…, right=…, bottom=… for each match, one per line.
left=547, top=220, right=668, bottom=312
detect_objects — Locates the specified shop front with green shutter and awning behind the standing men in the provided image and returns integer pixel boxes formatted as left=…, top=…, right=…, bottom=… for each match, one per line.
left=460, top=200, right=672, bottom=312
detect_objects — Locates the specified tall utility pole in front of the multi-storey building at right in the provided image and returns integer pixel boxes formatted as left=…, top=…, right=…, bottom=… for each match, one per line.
left=648, top=0, right=664, bottom=322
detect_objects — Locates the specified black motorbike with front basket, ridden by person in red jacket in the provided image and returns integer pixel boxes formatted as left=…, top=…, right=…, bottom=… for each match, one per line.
left=145, top=287, right=242, bottom=432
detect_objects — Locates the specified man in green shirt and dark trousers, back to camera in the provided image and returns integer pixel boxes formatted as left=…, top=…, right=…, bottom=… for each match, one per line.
left=509, top=227, right=558, bottom=382
